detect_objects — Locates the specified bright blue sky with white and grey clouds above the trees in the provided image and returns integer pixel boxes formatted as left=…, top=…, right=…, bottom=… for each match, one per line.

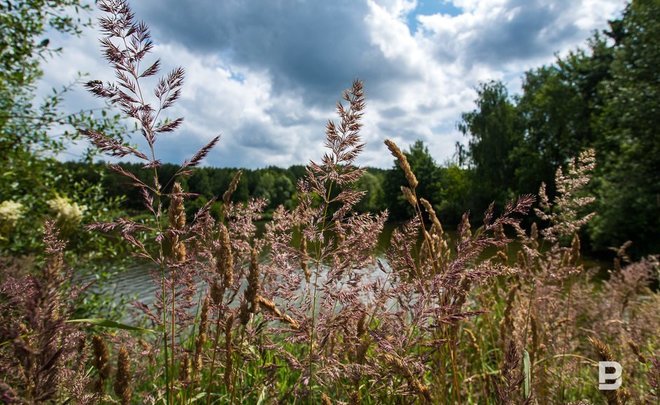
left=39, top=0, right=625, bottom=168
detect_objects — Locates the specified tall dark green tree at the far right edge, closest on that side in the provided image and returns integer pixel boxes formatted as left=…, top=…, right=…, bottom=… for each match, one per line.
left=591, top=0, right=660, bottom=255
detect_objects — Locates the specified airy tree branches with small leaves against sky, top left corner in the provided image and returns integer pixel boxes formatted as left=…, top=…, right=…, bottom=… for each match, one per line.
left=0, top=0, right=98, bottom=164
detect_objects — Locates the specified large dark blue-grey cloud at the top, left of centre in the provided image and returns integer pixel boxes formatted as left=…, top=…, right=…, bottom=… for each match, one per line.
left=130, top=0, right=403, bottom=105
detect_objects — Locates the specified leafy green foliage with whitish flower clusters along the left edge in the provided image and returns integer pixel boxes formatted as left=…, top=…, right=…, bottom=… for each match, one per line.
left=0, top=0, right=130, bottom=254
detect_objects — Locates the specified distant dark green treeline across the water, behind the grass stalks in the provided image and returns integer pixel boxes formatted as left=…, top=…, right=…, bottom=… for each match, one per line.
left=61, top=152, right=471, bottom=226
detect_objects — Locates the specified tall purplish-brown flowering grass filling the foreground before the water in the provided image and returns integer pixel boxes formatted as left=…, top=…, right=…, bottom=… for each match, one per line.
left=0, top=1, right=660, bottom=404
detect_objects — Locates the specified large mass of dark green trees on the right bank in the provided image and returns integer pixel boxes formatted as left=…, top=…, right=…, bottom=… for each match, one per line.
left=459, top=0, right=660, bottom=257
